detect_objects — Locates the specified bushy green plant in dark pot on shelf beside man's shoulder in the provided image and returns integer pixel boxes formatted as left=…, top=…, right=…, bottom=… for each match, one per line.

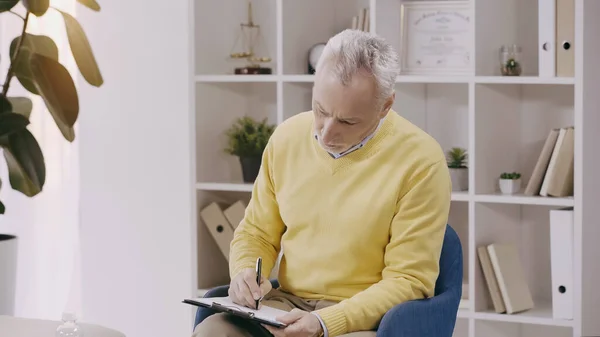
left=225, top=116, right=275, bottom=183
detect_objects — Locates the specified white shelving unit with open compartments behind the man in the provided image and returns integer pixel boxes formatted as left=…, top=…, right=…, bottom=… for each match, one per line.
left=191, top=0, right=600, bottom=337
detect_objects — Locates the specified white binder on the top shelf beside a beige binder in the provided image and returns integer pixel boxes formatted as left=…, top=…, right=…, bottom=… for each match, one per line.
left=538, top=0, right=556, bottom=78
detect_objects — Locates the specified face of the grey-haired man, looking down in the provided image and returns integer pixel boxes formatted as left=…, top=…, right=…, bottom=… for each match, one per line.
left=312, top=68, right=393, bottom=153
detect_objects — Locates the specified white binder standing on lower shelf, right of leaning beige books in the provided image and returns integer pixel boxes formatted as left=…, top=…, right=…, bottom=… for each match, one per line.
left=550, top=208, right=574, bottom=319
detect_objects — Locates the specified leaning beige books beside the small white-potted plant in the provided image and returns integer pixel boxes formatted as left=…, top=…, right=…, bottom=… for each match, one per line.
left=524, top=126, right=575, bottom=197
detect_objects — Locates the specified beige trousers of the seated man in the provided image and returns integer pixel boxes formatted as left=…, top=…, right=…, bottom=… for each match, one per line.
left=193, top=289, right=376, bottom=337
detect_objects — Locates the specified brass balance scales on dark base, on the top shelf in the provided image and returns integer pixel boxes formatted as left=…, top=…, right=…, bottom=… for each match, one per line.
left=230, top=1, right=272, bottom=75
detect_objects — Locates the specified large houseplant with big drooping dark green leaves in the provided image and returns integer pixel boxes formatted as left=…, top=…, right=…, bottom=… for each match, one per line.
left=0, top=0, right=104, bottom=214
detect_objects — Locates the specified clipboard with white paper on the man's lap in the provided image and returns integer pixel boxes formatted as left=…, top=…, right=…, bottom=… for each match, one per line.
left=183, top=297, right=287, bottom=328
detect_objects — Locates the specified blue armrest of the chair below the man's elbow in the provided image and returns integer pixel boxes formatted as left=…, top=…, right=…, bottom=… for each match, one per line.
left=377, top=292, right=460, bottom=337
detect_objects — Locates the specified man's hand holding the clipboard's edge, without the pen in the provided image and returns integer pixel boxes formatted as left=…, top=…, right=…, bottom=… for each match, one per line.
left=263, top=309, right=323, bottom=337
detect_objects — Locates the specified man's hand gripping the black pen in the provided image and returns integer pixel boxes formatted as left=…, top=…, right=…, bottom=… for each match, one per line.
left=229, top=268, right=272, bottom=309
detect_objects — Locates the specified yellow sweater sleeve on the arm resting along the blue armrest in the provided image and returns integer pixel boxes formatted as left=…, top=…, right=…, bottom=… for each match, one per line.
left=316, top=160, right=452, bottom=337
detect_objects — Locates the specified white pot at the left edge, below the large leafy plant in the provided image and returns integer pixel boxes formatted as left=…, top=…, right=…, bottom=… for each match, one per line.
left=0, top=234, right=17, bottom=316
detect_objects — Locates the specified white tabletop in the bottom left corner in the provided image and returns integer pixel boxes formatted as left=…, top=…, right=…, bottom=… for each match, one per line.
left=0, top=315, right=125, bottom=337
